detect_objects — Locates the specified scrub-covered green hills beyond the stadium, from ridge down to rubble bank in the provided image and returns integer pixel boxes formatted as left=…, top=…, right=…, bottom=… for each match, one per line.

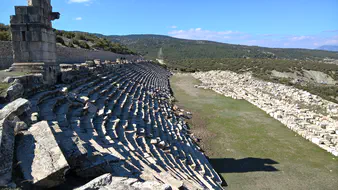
left=103, top=35, right=338, bottom=102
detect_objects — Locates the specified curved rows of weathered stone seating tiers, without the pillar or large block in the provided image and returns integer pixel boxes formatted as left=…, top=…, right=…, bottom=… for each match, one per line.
left=23, top=63, right=222, bottom=189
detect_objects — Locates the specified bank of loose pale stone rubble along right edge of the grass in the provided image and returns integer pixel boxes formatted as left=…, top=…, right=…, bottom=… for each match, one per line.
left=193, top=71, right=338, bottom=156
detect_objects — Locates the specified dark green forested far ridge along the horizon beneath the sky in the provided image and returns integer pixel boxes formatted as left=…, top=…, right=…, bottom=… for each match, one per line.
left=96, top=34, right=338, bottom=61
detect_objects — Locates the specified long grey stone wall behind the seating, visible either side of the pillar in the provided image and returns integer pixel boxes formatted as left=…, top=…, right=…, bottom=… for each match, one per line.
left=0, top=41, right=137, bottom=70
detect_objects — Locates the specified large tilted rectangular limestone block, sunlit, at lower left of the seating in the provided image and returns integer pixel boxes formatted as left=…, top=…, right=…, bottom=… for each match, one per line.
left=16, top=121, right=69, bottom=188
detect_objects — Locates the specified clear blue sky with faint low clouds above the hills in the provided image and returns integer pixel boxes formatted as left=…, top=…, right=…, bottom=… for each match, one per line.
left=0, top=0, right=338, bottom=48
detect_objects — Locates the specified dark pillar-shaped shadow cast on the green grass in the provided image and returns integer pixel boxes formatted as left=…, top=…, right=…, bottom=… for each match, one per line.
left=209, top=157, right=278, bottom=173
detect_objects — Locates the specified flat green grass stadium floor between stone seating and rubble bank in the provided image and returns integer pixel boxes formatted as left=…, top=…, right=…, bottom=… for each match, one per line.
left=171, top=74, right=338, bottom=190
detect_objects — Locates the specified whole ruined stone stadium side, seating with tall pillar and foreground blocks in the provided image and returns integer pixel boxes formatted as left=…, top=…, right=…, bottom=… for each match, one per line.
left=0, top=0, right=224, bottom=189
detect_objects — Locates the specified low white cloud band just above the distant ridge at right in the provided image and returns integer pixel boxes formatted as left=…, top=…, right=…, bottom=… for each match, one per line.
left=168, top=28, right=338, bottom=49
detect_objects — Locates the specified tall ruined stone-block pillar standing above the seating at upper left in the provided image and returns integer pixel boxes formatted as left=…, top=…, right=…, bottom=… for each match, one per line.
left=10, top=0, right=60, bottom=83
